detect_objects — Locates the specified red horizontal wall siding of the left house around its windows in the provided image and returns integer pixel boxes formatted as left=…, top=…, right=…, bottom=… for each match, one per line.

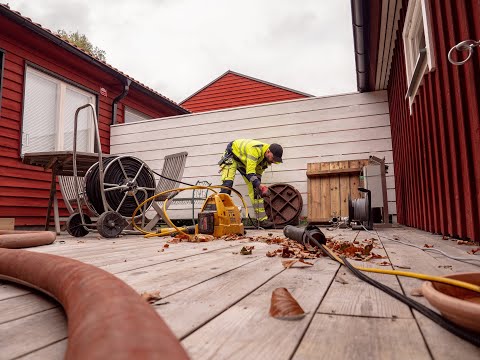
left=0, top=16, right=182, bottom=226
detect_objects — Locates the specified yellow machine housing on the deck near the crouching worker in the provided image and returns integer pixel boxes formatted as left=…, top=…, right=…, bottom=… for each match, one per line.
left=196, top=194, right=245, bottom=237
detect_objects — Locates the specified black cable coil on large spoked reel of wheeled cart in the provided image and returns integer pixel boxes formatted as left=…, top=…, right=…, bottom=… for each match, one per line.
left=85, top=156, right=155, bottom=217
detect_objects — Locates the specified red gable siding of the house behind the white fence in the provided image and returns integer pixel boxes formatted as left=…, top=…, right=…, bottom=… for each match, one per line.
left=182, top=73, right=306, bottom=112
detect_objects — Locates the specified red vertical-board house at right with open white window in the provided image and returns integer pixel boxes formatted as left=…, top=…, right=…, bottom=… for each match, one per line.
left=351, top=0, right=480, bottom=241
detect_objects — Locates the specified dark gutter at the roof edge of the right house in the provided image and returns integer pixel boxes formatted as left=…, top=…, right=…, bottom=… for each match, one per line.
left=350, top=0, right=369, bottom=92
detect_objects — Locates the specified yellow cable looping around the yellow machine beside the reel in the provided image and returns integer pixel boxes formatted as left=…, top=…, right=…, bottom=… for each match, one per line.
left=132, top=185, right=248, bottom=238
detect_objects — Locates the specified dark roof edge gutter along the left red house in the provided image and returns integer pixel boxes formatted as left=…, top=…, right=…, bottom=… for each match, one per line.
left=0, top=6, right=190, bottom=114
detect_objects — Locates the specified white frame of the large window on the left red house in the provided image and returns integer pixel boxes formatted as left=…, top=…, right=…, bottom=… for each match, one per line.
left=21, top=65, right=97, bottom=157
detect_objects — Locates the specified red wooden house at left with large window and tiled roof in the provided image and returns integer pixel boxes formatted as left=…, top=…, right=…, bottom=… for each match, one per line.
left=0, top=5, right=188, bottom=226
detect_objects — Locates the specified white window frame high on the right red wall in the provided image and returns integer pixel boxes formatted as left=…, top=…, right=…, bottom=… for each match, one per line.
left=402, top=0, right=435, bottom=112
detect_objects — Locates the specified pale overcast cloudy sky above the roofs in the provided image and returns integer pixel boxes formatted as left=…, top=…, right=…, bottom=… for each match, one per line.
left=9, top=0, right=356, bottom=102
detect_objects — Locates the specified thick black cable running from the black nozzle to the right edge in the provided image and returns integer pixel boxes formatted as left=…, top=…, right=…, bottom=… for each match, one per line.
left=306, top=231, right=480, bottom=346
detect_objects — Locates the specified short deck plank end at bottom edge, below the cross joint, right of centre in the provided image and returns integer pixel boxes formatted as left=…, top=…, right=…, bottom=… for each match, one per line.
left=293, top=314, right=431, bottom=360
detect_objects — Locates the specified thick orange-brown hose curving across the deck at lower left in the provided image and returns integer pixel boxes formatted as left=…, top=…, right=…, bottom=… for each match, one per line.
left=0, top=231, right=188, bottom=360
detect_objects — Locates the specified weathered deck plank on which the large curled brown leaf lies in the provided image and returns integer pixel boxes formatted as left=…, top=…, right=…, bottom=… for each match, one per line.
left=183, top=258, right=339, bottom=360
